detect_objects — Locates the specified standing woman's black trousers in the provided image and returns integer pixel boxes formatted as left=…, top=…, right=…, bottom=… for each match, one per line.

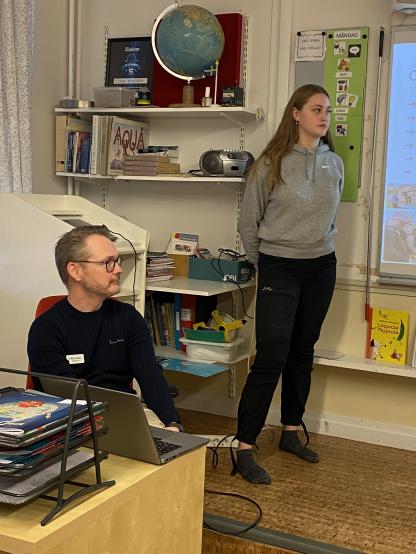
left=236, top=252, right=336, bottom=444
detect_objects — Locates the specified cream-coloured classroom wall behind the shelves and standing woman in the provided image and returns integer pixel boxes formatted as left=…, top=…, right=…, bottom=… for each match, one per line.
left=28, top=0, right=416, bottom=448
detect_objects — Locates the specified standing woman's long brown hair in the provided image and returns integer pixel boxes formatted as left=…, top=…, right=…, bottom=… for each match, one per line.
left=249, top=84, right=334, bottom=191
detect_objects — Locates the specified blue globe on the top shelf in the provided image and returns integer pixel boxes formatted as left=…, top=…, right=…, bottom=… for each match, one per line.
left=152, top=4, right=224, bottom=82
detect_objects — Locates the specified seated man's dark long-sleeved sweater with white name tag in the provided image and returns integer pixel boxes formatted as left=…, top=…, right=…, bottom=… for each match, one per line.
left=27, top=299, right=179, bottom=425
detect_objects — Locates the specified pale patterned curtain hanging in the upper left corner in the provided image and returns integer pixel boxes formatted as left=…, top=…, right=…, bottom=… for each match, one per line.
left=0, top=0, right=35, bottom=192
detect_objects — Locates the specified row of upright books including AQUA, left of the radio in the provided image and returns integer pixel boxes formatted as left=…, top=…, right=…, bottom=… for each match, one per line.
left=56, top=114, right=179, bottom=175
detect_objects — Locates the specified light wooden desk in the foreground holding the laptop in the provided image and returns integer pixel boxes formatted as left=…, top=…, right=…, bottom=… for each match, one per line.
left=0, top=447, right=205, bottom=554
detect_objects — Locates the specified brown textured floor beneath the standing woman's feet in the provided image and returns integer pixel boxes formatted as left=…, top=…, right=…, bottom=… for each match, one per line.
left=181, top=410, right=416, bottom=554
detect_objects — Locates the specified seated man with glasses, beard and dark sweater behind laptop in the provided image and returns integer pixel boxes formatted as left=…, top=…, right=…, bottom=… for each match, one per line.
left=28, top=225, right=181, bottom=431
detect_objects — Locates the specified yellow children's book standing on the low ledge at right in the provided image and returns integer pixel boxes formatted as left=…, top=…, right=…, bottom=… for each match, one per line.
left=367, top=308, right=409, bottom=365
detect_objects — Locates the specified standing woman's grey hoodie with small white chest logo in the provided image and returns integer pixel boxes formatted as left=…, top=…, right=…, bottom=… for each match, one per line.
left=238, top=144, right=344, bottom=266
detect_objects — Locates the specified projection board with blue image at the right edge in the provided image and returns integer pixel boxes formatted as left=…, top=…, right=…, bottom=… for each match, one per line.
left=379, top=27, right=416, bottom=284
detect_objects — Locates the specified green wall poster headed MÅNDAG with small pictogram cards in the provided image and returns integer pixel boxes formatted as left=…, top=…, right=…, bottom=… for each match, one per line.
left=324, top=27, right=368, bottom=202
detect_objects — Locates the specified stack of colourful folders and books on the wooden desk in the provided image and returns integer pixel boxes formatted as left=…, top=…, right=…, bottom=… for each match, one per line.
left=0, top=387, right=107, bottom=504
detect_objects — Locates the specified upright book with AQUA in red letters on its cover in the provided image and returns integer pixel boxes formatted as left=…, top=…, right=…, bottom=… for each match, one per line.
left=107, top=116, right=149, bottom=175
